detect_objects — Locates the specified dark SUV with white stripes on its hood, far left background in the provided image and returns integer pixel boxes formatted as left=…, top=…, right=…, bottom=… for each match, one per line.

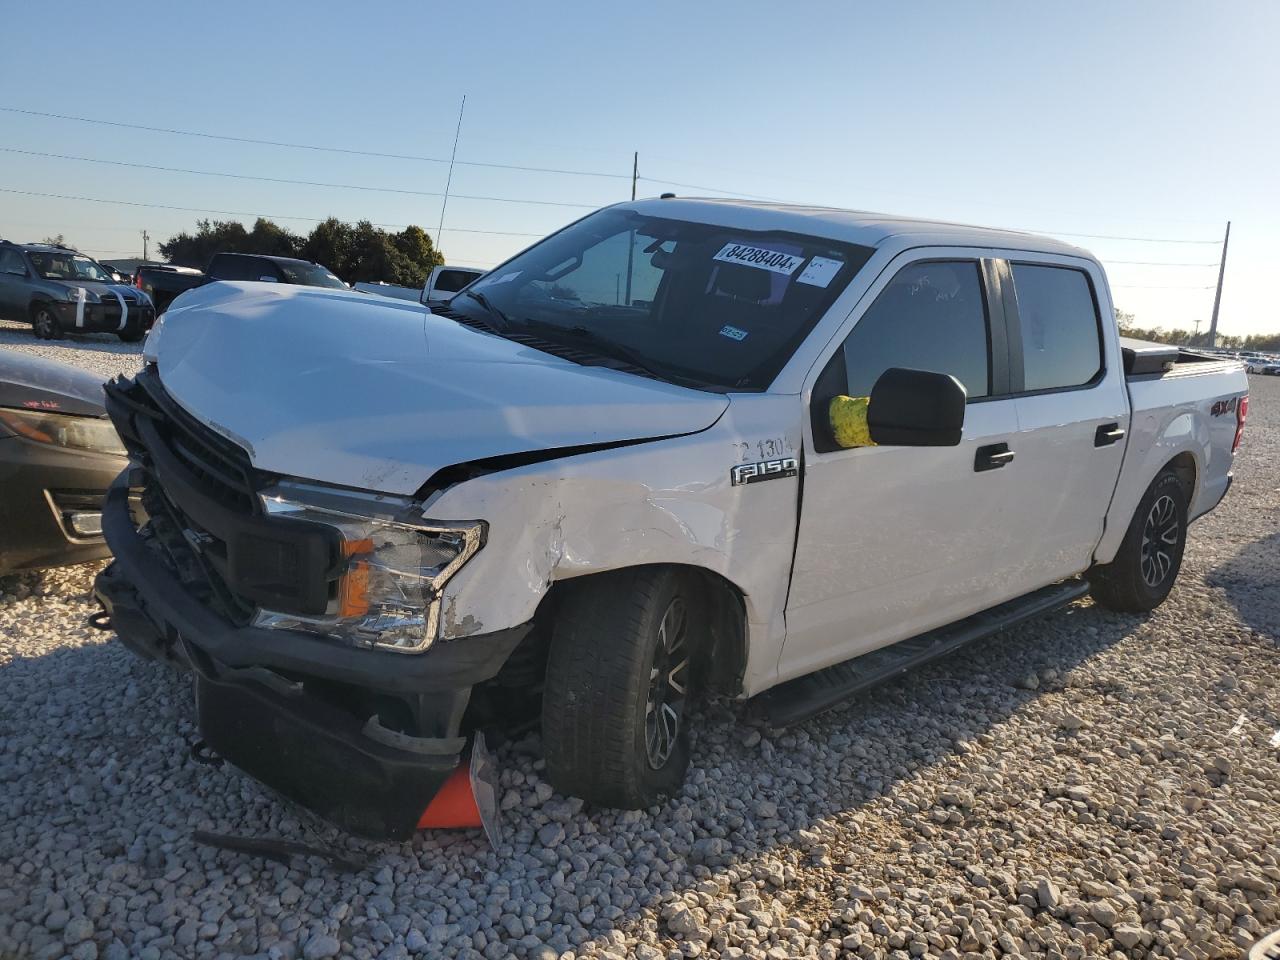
left=0, top=241, right=156, bottom=343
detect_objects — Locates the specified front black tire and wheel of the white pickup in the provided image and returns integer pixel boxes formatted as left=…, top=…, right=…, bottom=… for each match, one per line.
left=543, top=567, right=704, bottom=810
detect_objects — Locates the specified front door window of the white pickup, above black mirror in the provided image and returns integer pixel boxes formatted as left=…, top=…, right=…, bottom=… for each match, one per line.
left=845, top=261, right=991, bottom=399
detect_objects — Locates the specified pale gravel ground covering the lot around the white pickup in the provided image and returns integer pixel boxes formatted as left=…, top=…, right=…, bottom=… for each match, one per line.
left=0, top=345, right=1280, bottom=960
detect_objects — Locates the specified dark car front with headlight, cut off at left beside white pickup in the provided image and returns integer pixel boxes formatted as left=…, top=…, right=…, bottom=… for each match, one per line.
left=0, top=351, right=128, bottom=573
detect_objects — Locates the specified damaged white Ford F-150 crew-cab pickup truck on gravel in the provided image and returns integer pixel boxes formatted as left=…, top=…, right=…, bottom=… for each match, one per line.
left=96, top=198, right=1248, bottom=837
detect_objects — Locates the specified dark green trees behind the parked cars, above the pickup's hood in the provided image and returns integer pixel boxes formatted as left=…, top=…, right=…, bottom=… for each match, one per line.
left=160, top=216, right=444, bottom=287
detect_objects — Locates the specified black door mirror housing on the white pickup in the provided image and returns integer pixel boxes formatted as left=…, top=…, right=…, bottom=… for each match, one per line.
left=867, top=366, right=966, bottom=447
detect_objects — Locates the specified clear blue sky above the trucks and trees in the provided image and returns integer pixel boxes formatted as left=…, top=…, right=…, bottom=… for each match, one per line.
left=0, top=0, right=1280, bottom=333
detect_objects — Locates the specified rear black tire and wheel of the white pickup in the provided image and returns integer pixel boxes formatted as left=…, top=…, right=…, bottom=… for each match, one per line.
left=1085, top=470, right=1187, bottom=613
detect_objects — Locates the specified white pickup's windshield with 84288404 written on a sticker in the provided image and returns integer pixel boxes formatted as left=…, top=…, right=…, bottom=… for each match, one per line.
left=449, top=210, right=872, bottom=390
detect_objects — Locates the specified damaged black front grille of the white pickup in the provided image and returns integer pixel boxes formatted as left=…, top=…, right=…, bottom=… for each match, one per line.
left=106, top=369, right=340, bottom=626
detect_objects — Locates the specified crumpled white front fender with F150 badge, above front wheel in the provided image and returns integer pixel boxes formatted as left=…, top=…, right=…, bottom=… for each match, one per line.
left=426, top=396, right=800, bottom=692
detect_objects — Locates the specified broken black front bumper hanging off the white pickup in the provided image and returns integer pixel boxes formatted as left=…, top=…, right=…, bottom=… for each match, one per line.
left=95, top=481, right=530, bottom=840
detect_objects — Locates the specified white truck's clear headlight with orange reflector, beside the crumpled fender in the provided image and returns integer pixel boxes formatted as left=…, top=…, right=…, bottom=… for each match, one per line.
left=253, top=488, right=486, bottom=653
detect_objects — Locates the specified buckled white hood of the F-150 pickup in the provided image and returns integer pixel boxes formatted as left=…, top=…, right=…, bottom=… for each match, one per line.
left=145, top=283, right=728, bottom=494
